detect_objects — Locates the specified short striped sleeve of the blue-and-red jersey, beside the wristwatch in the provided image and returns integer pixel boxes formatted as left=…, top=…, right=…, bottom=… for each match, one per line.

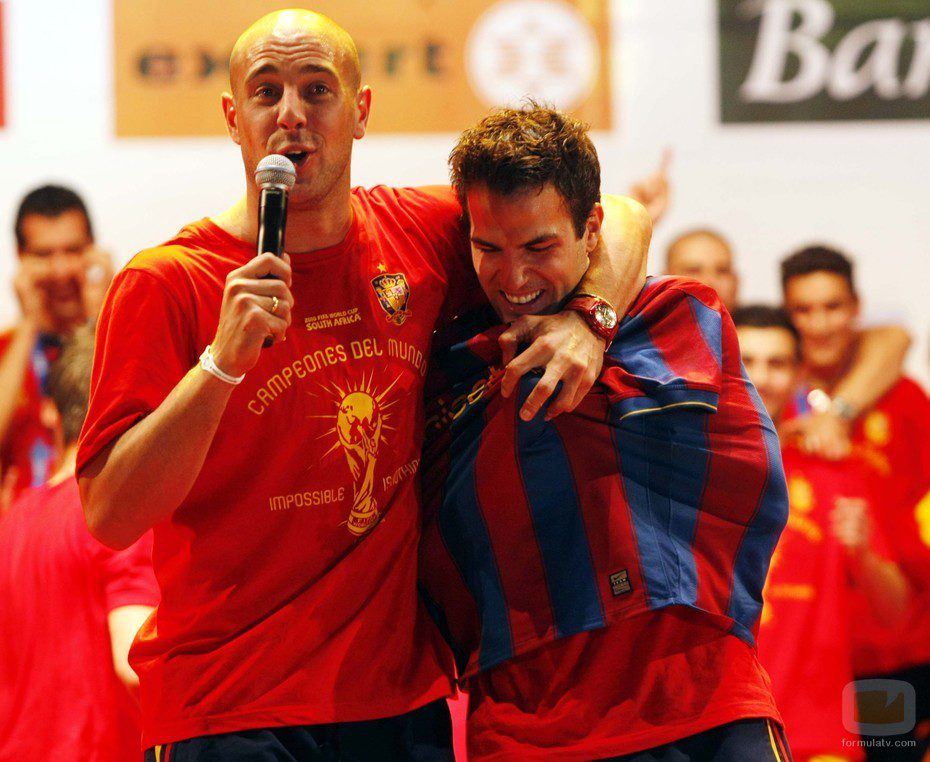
left=600, top=279, right=724, bottom=420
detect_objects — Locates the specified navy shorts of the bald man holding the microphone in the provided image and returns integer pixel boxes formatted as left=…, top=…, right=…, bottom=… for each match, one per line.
left=145, top=699, right=453, bottom=762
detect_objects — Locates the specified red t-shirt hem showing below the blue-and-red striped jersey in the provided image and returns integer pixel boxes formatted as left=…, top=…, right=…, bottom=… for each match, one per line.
left=466, top=606, right=790, bottom=762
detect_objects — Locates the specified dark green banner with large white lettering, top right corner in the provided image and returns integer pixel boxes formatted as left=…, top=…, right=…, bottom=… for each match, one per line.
left=718, top=0, right=930, bottom=122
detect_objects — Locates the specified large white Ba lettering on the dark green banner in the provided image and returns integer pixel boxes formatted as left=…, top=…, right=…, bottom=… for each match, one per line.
left=739, top=0, right=930, bottom=103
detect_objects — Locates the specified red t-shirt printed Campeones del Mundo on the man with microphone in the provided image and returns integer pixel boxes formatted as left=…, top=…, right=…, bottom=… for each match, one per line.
left=78, top=187, right=475, bottom=746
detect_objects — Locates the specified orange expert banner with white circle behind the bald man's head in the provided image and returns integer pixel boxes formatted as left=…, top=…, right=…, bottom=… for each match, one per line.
left=113, top=0, right=611, bottom=136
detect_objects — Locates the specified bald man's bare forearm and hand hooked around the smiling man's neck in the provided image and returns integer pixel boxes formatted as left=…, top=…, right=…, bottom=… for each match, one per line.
left=501, top=196, right=652, bottom=420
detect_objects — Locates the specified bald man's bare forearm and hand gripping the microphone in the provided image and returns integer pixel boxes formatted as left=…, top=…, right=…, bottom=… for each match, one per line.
left=78, top=254, right=294, bottom=548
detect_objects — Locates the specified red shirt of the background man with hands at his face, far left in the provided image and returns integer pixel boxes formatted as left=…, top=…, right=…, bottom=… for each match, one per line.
left=0, top=331, right=58, bottom=493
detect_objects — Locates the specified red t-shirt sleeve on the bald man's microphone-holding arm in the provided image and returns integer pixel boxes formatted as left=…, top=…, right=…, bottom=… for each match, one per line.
left=77, top=269, right=193, bottom=474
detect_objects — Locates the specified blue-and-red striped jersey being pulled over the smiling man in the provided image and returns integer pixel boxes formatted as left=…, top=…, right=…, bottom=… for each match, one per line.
left=420, top=278, right=788, bottom=677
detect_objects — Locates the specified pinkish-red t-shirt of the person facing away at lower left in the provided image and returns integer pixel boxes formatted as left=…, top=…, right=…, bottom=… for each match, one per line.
left=0, top=479, right=158, bottom=762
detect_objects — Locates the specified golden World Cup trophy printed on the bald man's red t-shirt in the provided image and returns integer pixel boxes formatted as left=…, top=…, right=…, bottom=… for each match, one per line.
left=336, top=391, right=383, bottom=535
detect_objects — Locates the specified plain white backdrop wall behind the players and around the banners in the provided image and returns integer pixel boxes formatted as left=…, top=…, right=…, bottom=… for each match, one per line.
left=0, top=0, right=930, bottom=382
